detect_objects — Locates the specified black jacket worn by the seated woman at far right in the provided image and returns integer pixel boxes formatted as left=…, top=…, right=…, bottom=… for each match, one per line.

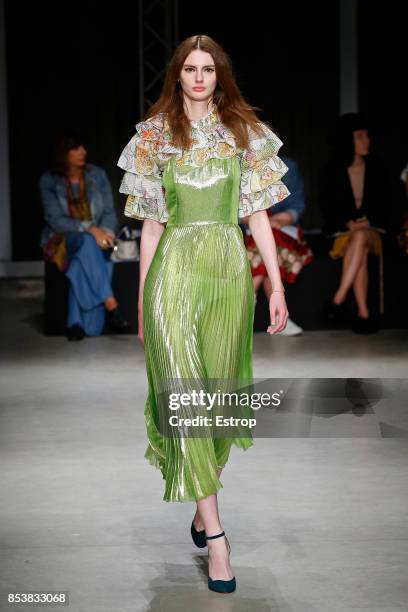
left=319, top=155, right=392, bottom=235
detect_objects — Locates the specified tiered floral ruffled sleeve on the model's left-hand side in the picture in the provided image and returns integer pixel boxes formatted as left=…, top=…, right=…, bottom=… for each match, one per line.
left=118, top=118, right=169, bottom=223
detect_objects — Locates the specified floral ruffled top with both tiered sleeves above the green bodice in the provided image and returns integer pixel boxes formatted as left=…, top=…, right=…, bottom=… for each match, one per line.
left=118, top=107, right=290, bottom=223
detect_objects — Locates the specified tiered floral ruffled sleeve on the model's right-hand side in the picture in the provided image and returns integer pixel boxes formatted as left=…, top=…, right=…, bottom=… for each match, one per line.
left=238, top=123, right=290, bottom=217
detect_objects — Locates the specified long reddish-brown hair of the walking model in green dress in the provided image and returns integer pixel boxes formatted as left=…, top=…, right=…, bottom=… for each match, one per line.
left=145, top=34, right=262, bottom=149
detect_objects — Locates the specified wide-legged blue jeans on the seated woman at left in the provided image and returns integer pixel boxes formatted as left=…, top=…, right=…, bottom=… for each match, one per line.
left=65, top=232, right=113, bottom=336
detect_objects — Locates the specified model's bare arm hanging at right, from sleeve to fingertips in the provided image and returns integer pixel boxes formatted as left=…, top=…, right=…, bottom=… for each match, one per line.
left=248, top=210, right=288, bottom=334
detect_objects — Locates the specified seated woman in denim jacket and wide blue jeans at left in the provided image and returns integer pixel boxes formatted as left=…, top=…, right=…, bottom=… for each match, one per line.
left=39, top=135, right=130, bottom=340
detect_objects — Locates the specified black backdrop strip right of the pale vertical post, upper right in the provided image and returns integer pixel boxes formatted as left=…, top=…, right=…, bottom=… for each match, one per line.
left=358, top=0, right=408, bottom=224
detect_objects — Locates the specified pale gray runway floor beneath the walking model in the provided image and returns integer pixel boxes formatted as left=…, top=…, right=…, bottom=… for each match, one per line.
left=0, top=281, right=408, bottom=612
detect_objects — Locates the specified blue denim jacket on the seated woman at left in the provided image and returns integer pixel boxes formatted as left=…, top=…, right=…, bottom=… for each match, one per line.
left=39, top=164, right=118, bottom=245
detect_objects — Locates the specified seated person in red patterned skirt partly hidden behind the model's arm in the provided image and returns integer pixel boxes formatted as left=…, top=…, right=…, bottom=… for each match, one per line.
left=243, top=155, right=313, bottom=336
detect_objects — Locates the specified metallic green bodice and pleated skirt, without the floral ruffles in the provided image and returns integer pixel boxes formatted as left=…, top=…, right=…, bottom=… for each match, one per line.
left=143, top=156, right=254, bottom=502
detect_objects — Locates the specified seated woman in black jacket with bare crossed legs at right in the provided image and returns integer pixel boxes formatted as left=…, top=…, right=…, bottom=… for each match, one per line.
left=320, top=113, right=391, bottom=333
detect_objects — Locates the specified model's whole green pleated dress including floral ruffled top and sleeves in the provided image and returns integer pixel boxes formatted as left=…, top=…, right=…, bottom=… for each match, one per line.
left=118, top=108, right=289, bottom=502
